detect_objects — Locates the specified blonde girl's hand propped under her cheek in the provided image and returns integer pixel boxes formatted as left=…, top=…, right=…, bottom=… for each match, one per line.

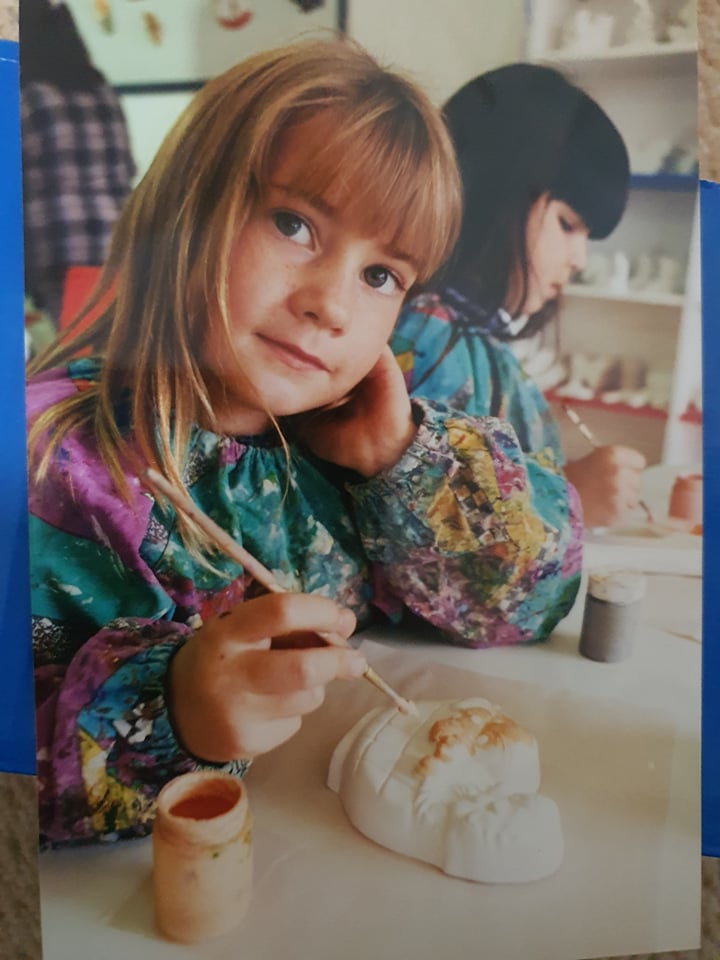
left=298, top=347, right=417, bottom=477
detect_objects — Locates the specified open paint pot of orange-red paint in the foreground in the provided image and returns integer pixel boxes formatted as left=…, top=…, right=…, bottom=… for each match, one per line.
left=153, top=771, right=252, bottom=943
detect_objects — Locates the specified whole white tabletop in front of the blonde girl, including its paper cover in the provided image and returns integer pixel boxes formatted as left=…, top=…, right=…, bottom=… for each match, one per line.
left=40, top=576, right=701, bottom=960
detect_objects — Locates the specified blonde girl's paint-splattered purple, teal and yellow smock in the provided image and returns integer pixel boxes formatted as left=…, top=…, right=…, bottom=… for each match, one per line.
left=27, top=359, right=582, bottom=843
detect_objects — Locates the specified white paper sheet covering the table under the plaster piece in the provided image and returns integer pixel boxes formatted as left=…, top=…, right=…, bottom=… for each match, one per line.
left=41, top=642, right=700, bottom=960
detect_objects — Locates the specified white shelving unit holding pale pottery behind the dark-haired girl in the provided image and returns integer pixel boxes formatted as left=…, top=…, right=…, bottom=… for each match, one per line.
left=526, top=0, right=702, bottom=463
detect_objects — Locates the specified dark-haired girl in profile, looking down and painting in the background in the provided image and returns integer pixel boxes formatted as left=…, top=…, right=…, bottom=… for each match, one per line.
left=392, top=63, right=645, bottom=526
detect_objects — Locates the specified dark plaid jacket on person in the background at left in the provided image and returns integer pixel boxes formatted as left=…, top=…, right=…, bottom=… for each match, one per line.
left=20, top=82, right=135, bottom=305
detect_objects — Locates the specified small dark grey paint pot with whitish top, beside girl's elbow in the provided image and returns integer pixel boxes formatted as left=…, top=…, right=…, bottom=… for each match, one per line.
left=580, top=570, right=645, bottom=663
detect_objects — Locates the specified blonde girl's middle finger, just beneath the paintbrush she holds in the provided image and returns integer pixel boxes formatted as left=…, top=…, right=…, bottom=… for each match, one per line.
left=238, top=647, right=367, bottom=696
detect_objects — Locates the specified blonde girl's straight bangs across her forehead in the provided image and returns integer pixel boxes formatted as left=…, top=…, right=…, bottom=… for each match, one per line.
left=274, top=112, right=460, bottom=282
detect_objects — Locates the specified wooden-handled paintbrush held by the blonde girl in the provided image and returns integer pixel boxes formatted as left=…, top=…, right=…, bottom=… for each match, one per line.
left=142, top=467, right=418, bottom=716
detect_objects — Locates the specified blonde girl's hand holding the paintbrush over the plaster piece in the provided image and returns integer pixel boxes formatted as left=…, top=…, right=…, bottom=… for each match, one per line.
left=168, top=593, right=367, bottom=763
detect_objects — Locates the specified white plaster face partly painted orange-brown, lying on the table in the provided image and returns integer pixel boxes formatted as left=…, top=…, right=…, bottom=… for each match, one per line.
left=328, top=698, right=563, bottom=883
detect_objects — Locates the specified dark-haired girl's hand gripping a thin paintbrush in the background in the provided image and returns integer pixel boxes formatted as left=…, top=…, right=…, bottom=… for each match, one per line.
left=565, top=446, right=645, bottom=527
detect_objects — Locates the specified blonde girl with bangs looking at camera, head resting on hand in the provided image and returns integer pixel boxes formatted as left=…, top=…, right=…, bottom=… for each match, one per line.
left=28, top=42, right=581, bottom=843
